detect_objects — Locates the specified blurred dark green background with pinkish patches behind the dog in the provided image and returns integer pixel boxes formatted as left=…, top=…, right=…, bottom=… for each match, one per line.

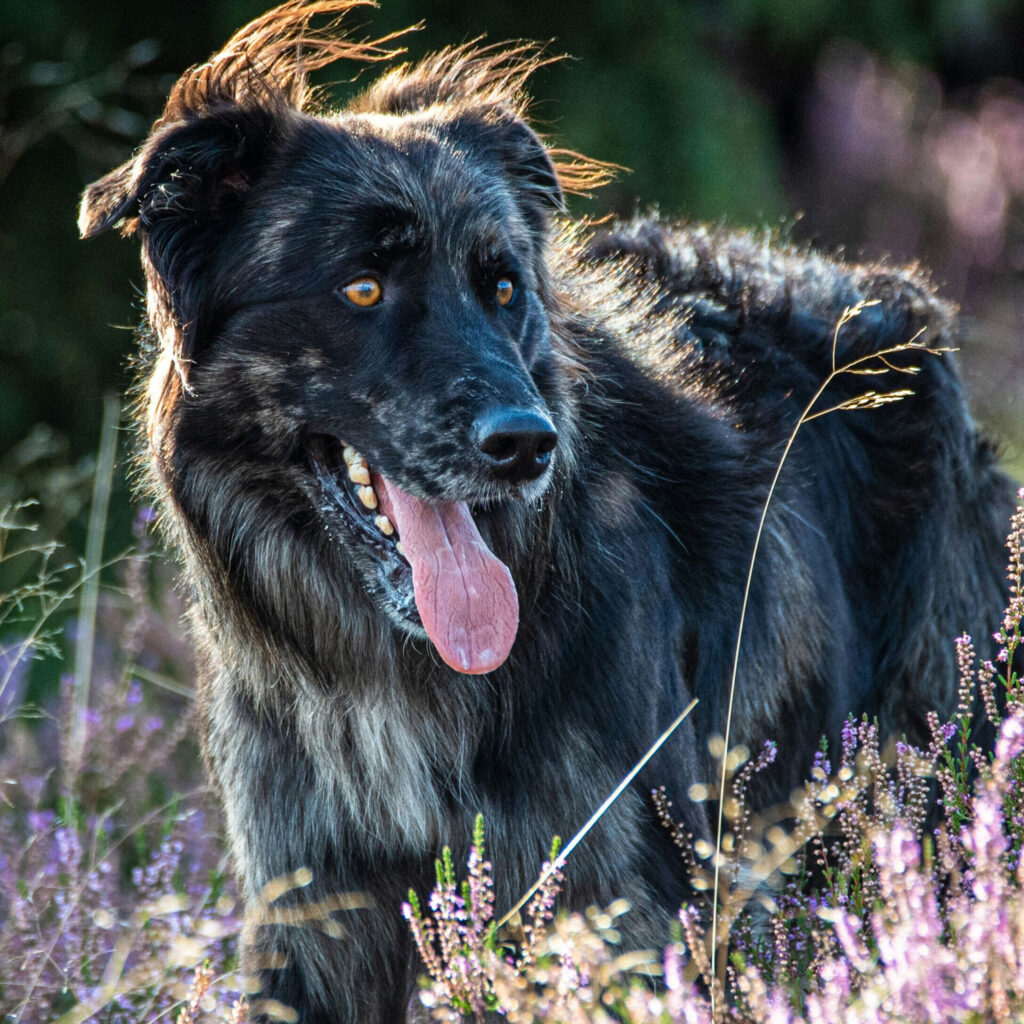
left=0, top=0, right=1024, bottom=550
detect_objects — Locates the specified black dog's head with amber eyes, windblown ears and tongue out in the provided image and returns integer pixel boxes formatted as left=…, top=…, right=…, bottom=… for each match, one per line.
left=80, top=0, right=600, bottom=672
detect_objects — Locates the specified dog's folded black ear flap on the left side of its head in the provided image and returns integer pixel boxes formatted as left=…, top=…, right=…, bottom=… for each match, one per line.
left=78, top=104, right=281, bottom=238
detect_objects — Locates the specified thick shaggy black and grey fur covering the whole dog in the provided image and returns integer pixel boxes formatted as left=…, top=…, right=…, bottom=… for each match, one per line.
left=81, top=0, right=1010, bottom=1024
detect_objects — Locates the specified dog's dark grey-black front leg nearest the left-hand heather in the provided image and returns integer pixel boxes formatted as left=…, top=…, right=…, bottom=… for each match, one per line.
left=201, top=675, right=419, bottom=1024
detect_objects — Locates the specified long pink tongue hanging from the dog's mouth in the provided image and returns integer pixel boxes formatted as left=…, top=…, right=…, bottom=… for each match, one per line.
left=373, top=473, right=519, bottom=674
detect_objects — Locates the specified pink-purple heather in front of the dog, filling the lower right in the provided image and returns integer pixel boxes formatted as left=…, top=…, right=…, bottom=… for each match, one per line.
left=404, top=488, right=1024, bottom=1024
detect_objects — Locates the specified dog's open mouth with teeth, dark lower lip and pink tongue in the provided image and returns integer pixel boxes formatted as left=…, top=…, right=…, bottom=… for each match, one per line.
left=306, top=436, right=519, bottom=674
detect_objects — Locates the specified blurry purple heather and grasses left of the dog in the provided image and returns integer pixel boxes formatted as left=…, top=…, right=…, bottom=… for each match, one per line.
left=0, top=506, right=245, bottom=1024
